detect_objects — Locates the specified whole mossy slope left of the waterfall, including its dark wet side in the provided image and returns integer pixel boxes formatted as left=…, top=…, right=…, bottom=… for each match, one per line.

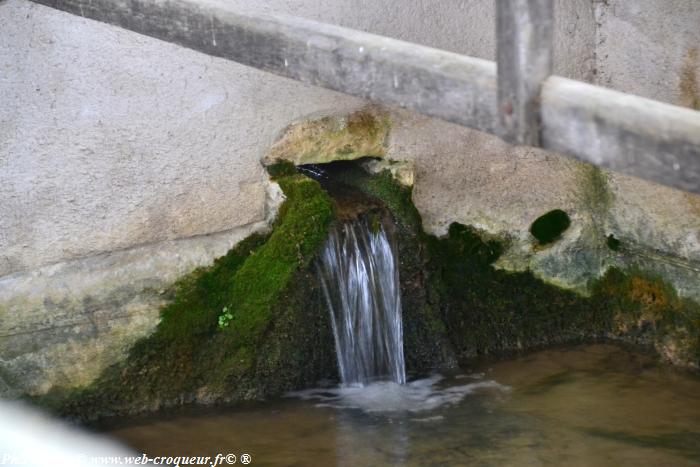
left=42, top=173, right=335, bottom=418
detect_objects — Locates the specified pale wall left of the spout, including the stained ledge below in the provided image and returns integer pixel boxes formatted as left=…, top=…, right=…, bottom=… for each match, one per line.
left=0, top=0, right=363, bottom=394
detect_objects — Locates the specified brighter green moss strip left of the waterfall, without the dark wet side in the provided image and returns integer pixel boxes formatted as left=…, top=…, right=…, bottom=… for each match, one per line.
left=43, top=175, right=334, bottom=417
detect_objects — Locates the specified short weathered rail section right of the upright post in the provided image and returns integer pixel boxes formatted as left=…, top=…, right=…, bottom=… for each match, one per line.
left=541, top=76, right=700, bottom=193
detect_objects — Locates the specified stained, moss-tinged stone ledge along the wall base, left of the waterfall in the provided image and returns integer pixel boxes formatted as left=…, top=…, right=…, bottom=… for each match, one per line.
left=0, top=222, right=268, bottom=397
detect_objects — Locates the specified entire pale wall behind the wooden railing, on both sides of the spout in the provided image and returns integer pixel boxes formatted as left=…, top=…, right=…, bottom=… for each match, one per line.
left=0, top=0, right=700, bottom=394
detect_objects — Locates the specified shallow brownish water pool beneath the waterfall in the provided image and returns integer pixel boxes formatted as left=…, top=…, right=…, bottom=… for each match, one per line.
left=101, top=345, right=700, bottom=467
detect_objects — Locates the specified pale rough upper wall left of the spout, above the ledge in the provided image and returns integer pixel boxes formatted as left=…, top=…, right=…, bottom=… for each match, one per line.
left=0, top=0, right=365, bottom=276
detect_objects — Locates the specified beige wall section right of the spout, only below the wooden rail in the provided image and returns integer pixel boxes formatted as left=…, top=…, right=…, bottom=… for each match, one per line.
left=386, top=111, right=700, bottom=300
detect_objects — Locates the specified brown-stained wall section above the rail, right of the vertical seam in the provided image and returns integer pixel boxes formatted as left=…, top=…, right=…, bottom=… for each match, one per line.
left=594, top=0, right=700, bottom=108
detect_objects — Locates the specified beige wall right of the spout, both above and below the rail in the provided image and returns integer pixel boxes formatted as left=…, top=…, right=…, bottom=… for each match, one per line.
left=396, top=0, right=700, bottom=300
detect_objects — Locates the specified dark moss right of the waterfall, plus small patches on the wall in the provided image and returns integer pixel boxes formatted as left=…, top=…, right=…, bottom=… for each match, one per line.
left=308, top=162, right=700, bottom=367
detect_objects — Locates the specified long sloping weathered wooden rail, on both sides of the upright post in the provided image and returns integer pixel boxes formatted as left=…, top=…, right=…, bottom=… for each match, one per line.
left=27, top=0, right=700, bottom=193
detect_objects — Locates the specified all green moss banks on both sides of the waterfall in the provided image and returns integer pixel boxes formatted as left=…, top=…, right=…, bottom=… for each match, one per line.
left=34, top=163, right=700, bottom=417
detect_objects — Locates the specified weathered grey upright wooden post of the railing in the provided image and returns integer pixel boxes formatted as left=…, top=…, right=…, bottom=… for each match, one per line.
left=496, top=0, right=554, bottom=146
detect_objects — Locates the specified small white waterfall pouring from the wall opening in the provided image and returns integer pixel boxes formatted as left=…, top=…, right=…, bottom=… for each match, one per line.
left=318, top=220, right=406, bottom=386
